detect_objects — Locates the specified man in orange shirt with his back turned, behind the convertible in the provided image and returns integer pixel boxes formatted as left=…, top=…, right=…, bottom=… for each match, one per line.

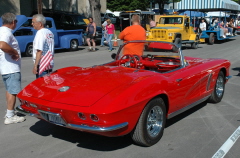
left=119, top=14, right=146, bottom=56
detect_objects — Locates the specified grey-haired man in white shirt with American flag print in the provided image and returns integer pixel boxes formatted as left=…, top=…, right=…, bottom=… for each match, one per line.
left=32, top=14, right=54, bottom=78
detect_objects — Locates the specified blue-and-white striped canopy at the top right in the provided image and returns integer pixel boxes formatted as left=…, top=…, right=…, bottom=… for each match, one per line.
left=178, top=0, right=240, bottom=12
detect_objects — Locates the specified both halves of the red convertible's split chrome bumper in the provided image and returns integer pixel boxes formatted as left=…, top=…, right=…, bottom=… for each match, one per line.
left=16, top=105, right=128, bottom=132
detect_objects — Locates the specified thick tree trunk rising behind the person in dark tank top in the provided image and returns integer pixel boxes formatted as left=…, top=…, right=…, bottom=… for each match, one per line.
left=89, top=0, right=101, bottom=26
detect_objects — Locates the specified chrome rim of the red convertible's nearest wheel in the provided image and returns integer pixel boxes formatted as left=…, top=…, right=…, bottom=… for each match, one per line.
left=147, top=106, right=163, bottom=137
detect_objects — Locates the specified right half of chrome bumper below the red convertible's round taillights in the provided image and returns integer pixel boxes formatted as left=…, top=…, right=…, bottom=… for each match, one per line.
left=68, top=122, right=128, bottom=132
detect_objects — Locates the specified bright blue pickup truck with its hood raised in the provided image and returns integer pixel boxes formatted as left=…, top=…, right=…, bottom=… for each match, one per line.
left=0, top=15, right=83, bottom=56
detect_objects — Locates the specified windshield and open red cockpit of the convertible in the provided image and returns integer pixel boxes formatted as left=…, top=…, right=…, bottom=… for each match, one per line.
left=110, top=41, right=187, bottom=73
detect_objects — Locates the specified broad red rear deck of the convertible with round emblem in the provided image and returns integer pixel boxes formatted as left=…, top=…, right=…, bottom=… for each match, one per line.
left=18, top=66, right=154, bottom=106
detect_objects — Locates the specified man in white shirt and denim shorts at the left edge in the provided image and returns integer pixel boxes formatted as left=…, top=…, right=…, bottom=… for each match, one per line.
left=0, top=13, right=25, bottom=125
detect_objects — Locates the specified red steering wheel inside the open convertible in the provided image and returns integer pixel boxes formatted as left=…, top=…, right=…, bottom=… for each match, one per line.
left=118, top=54, right=141, bottom=68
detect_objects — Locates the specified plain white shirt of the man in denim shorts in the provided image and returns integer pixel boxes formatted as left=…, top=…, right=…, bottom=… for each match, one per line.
left=0, top=26, right=21, bottom=75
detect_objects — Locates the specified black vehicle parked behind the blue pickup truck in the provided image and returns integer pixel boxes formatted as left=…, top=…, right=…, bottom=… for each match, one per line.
left=32, top=9, right=102, bottom=45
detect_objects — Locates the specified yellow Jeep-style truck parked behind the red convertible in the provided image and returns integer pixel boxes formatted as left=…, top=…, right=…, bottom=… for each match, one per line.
left=147, top=15, right=199, bottom=49
